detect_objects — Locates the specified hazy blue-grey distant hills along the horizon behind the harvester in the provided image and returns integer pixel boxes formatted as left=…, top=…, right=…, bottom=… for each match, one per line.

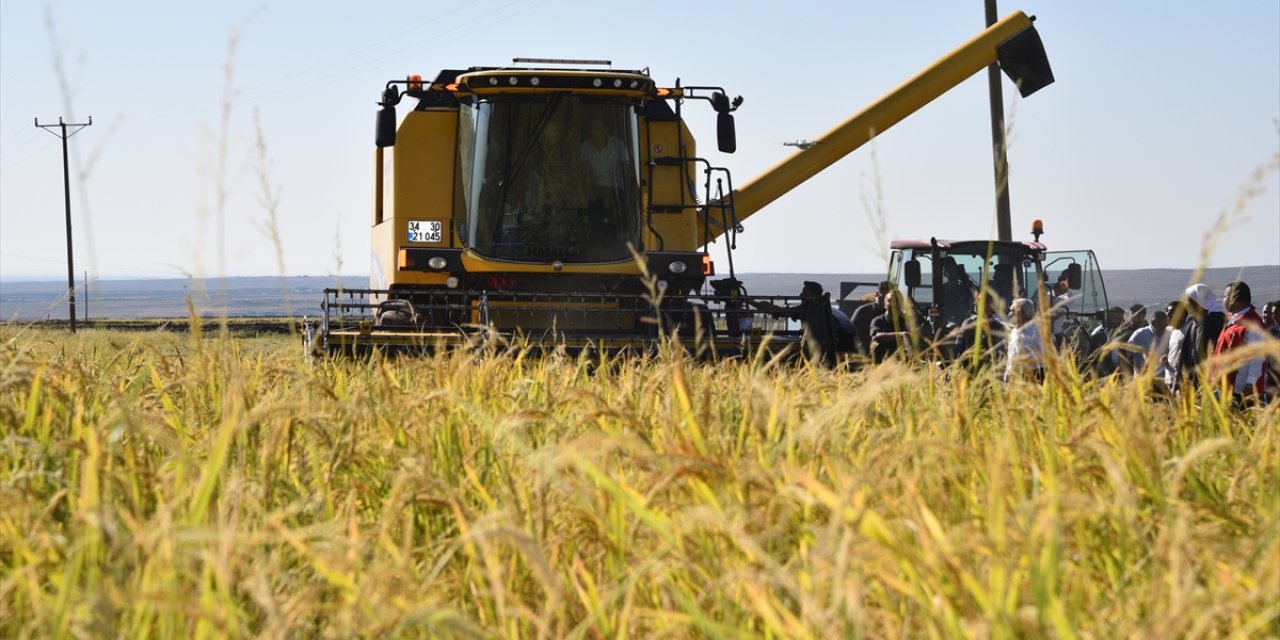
left=0, top=265, right=1280, bottom=321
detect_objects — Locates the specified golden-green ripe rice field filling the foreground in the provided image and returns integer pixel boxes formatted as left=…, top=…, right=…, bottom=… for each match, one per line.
left=0, top=325, right=1280, bottom=639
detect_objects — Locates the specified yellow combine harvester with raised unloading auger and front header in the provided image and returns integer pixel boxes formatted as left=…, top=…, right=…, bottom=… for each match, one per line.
left=307, top=12, right=1075, bottom=356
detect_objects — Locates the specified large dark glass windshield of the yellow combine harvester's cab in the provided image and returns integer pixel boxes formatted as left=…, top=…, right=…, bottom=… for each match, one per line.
left=458, top=93, right=640, bottom=262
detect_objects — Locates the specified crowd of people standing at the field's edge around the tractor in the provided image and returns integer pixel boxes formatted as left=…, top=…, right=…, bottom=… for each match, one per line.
left=851, top=282, right=1280, bottom=402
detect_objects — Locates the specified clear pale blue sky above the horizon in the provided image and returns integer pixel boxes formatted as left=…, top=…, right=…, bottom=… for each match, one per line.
left=0, top=0, right=1280, bottom=280
